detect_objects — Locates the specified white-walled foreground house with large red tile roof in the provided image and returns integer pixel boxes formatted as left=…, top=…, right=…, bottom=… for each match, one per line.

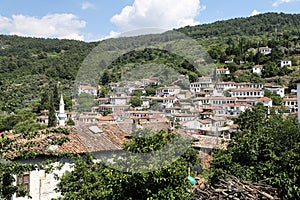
left=11, top=124, right=127, bottom=200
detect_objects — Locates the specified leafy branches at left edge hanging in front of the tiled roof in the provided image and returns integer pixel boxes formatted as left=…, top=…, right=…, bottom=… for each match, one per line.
left=0, top=125, right=69, bottom=199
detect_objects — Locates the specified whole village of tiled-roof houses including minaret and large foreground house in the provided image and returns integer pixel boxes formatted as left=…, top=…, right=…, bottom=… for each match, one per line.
left=24, top=63, right=298, bottom=199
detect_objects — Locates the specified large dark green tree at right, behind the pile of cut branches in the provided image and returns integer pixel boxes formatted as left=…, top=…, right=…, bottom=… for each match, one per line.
left=211, top=105, right=300, bottom=199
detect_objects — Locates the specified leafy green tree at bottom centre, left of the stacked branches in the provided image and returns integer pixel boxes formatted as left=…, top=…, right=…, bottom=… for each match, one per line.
left=58, top=129, right=199, bottom=200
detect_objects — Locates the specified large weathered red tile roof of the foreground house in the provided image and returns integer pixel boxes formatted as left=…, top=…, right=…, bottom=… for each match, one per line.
left=0, top=124, right=127, bottom=160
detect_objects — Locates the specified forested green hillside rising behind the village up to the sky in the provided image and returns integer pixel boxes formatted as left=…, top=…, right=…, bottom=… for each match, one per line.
left=0, top=13, right=300, bottom=113
